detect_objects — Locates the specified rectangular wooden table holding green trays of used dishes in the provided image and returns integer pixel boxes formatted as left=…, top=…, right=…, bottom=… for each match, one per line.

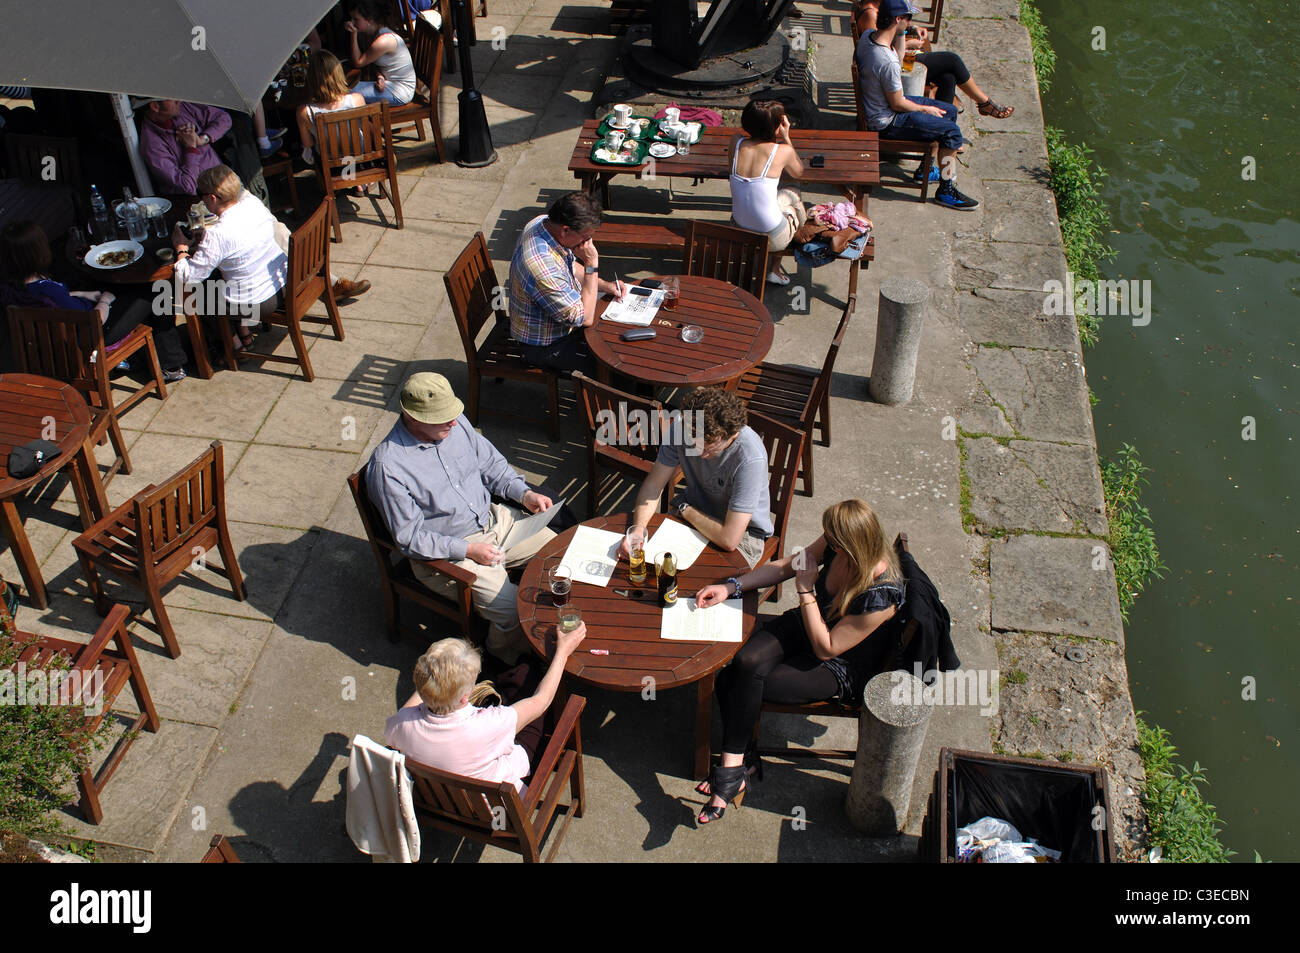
left=569, top=120, right=880, bottom=215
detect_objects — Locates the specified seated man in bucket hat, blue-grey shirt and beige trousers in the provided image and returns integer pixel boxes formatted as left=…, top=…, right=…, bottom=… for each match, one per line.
left=365, top=373, right=555, bottom=663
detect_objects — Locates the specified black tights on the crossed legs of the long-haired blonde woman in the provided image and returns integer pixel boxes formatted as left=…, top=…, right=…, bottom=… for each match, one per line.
left=716, top=608, right=840, bottom=754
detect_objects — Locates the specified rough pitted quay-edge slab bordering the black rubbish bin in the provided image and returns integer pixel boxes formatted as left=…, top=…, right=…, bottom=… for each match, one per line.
left=995, top=632, right=1145, bottom=861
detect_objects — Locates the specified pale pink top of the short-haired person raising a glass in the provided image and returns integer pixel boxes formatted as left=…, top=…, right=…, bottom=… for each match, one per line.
left=384, top=705, right=529, bottom=793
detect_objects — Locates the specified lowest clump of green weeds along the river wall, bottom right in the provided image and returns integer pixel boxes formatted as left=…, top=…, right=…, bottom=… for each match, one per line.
left=1138, top=712, right=1236, bottom=863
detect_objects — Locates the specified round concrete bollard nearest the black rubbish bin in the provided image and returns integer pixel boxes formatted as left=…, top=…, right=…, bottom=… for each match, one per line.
left=844, top=671, right=933, bottom=837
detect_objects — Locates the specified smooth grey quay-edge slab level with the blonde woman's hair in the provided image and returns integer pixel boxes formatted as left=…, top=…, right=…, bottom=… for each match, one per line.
left=989, top=536, right=1125, bottom=646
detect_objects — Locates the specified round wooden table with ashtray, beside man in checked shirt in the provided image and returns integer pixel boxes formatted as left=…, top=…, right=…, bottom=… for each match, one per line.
left=585, top=274, right=775, bottom=387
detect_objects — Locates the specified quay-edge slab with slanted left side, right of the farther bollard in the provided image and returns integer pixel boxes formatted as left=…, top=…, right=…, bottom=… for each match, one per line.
left=971, top=347, right=1096, bottom=446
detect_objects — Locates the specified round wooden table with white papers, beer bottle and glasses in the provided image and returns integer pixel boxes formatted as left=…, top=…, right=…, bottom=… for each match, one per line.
left=519, top=514, right=758, bottom=777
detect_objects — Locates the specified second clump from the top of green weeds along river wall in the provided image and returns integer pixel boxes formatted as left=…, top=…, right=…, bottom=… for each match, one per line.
left=1047, top=126, right=1115, bottom=346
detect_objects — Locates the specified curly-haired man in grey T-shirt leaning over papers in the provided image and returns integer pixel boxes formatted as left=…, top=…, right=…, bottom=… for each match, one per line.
left=623, top=387, right=774, bottom=567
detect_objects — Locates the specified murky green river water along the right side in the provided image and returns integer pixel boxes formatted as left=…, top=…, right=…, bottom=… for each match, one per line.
left=1034, top=0, right=1300, bottom=861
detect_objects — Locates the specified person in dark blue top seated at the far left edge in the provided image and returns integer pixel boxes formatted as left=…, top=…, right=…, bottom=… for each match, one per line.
left=0, top=221, right=185, bottom=384
